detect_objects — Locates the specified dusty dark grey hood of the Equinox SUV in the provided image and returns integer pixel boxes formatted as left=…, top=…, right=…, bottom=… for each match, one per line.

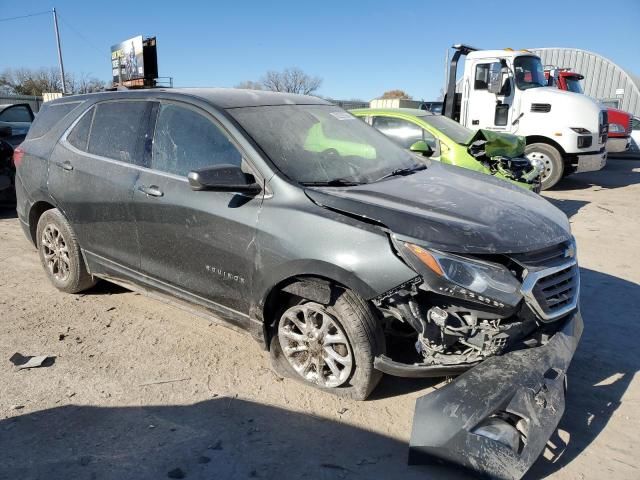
left=306, top=162, right=571, bottom=253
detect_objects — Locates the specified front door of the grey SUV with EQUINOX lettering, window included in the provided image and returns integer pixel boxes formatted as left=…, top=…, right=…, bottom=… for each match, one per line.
left=134, top=103, right=262, bottom=319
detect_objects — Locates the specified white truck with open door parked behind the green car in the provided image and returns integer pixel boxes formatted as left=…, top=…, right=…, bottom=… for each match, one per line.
left=443, top=45, right=608, bottom=189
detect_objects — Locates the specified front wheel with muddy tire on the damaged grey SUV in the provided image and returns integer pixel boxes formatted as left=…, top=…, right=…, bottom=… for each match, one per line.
left=271, top=289, right=385, bottom=400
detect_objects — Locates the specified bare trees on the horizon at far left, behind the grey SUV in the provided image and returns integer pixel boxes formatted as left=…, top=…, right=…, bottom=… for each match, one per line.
left=0, top=68, right=106, bottom=96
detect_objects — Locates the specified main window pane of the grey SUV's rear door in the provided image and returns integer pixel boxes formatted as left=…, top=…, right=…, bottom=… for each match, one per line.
left=88, top=101, right=149, bottom=163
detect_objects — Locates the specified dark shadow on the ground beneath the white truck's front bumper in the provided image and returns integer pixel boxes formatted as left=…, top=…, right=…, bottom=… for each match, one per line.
left=552, top=158, right=640, bottom=191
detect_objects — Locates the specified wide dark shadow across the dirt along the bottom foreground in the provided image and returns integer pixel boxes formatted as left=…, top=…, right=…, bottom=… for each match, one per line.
left=0, top=398, right=469, bottom=480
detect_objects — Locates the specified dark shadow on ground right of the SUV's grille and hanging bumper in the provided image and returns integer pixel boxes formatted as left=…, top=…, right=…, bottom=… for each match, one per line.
left=526, top=268, right=640, bottom=479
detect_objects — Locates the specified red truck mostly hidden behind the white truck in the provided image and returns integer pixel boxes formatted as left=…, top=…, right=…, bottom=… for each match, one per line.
left=544, top=66, right=631, bottom=153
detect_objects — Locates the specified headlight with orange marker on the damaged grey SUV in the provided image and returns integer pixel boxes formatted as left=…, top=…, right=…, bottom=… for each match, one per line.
left=398, top=242, right=522, bottom=307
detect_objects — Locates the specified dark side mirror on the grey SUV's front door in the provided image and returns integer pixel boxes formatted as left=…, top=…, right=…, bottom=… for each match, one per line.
left=187, top=165, right=262, bottom=194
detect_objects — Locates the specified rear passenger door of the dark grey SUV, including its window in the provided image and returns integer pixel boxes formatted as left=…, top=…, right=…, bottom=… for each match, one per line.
left=49, top=100, right=152, bottom=271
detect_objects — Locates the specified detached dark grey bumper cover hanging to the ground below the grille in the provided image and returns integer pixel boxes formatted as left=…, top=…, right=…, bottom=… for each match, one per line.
left=409, top=312, right=583, bottom=479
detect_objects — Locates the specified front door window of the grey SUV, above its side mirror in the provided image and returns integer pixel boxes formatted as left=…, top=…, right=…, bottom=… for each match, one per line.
left=151, top=104, right=242, bottom=176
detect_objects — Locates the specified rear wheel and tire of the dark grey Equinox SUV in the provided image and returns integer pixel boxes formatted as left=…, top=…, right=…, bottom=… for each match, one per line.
left=36, top=208, right=96, bottom=293
